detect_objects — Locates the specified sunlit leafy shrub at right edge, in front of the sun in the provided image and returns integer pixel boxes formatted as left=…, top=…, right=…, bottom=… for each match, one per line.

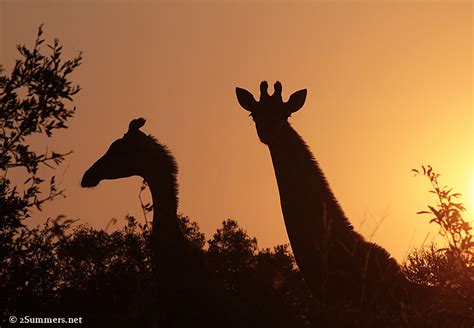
left=402, top=165, right=474, bottom=327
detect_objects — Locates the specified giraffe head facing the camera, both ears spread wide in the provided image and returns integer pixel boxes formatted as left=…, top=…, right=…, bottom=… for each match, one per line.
left=235, top=81, right=306, bottom=144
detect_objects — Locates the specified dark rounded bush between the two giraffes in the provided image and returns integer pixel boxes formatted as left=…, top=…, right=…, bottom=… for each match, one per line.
left=207, top=219, right=309, bottom=327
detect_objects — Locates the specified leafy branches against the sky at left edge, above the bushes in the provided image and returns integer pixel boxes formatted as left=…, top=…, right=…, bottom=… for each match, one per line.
left=0, top=27, right=82, bottom=258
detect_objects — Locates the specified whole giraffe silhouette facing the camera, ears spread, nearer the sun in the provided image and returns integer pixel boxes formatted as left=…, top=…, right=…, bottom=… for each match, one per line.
left=236, top=81, right=408, bottom=320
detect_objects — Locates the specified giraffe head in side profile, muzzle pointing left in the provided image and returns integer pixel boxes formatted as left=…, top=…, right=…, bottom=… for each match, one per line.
left=81, top=118, right=155, bottom=187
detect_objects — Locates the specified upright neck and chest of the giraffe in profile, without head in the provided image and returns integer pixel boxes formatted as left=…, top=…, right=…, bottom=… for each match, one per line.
left=144, top=144, right=226, bottom=327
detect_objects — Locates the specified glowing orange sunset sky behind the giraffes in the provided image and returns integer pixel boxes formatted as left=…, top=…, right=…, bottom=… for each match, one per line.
left=0, top=0, right=474, bottom=260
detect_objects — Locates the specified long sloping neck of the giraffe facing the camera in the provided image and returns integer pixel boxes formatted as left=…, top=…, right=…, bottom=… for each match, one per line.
left=268, top=124, right=361, bottom=297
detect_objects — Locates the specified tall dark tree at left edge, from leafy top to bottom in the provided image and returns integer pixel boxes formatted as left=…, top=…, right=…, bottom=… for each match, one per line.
left=0, top=26, right=82, bottom=317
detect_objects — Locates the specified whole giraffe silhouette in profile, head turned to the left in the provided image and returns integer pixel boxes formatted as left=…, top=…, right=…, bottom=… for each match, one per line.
left=81, top=118, right=229, bottom=327
